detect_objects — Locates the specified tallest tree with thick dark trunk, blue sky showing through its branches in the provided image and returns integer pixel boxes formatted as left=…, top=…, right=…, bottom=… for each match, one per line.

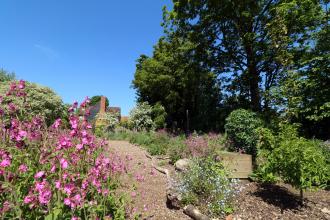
left=165, top=0, right=322, bottom=112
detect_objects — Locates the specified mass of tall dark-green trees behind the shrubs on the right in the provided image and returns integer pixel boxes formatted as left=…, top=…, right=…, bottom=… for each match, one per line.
left=133, top=0, right=330, bottom=139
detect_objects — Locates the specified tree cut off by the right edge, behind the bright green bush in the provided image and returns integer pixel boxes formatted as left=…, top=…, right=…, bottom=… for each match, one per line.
left=281, top=7, right=330, bottom=139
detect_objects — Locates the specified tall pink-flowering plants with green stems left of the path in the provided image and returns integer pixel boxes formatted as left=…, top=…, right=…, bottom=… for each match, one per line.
left=0, top=81, right=125, bottom=219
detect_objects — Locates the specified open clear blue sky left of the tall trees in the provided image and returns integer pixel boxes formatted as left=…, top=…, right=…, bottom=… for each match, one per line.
left=0, top=0, right=171, bottom=115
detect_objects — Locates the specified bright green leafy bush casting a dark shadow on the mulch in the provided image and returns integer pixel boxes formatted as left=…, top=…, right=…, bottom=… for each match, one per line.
left=257, top=124, right=330, bottom=194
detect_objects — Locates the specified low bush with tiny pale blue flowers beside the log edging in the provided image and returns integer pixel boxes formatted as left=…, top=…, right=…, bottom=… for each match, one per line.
left=178, top=158, right=237, bottom=217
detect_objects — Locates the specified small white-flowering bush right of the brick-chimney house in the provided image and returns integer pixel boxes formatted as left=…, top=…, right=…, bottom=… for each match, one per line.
left=129, top=102, right=155, bottom=131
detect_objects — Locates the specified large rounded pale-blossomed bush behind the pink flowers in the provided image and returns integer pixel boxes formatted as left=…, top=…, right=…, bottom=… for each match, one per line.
left=0, top=82, right=67, bottom=125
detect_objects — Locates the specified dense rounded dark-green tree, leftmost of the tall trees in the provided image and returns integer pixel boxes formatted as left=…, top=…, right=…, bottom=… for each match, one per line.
left=133, top=33, right=220, bottom=130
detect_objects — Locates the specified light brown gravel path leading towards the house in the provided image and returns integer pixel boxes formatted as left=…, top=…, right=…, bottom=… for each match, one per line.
left=109, top=141, right=190, bottom=220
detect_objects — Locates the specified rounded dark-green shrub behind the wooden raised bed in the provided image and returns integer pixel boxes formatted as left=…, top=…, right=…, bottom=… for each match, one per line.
left=225, top=109, right=262, bottom=155
